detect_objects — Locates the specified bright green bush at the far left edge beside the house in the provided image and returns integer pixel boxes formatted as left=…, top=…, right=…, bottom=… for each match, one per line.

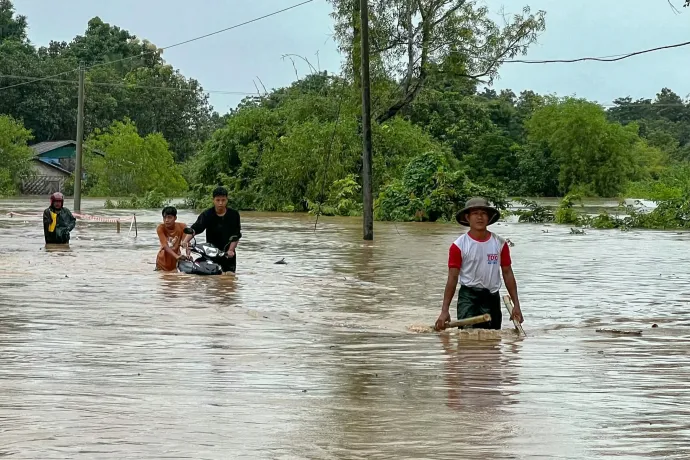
left=0, top=115, right=33, bottom=196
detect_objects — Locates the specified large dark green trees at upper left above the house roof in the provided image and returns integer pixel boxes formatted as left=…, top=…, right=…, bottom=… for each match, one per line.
left=0, top=0, right=217, bottom=161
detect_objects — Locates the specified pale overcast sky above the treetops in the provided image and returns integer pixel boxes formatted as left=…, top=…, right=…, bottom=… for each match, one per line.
left=14, top=0, right=690, bottom=113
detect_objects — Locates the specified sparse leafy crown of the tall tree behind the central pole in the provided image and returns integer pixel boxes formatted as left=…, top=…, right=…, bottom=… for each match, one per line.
left=331, top=0, right=545, bottom=123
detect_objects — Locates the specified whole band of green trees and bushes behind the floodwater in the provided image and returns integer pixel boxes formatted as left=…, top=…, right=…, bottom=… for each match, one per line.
left=0, top=0, right=690, bottom=226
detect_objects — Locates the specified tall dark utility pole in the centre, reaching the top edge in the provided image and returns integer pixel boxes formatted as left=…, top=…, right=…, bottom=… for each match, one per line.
left=360, top=0, right=374, bottom=240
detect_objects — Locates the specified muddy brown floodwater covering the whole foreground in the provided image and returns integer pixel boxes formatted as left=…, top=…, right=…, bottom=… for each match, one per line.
left=0, top=199, right=690, bottom=459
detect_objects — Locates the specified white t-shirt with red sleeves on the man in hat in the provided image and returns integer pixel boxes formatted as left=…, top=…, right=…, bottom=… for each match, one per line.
left=448, top=233, right=511, bottom=292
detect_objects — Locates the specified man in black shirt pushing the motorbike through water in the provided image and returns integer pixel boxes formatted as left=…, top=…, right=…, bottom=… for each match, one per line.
left=184, top=187, right=242, bottom=273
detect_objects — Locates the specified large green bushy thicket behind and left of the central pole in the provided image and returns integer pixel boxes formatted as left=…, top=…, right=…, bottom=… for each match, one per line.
left=183, top=76, right=443, bottom=215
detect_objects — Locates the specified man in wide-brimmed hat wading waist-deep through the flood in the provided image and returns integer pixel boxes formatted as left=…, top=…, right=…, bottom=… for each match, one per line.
left=436, top=198, right=523, bottom=330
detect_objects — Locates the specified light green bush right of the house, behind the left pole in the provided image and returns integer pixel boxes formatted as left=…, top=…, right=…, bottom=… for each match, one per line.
left=84, top=120, right=187, bottom=196
